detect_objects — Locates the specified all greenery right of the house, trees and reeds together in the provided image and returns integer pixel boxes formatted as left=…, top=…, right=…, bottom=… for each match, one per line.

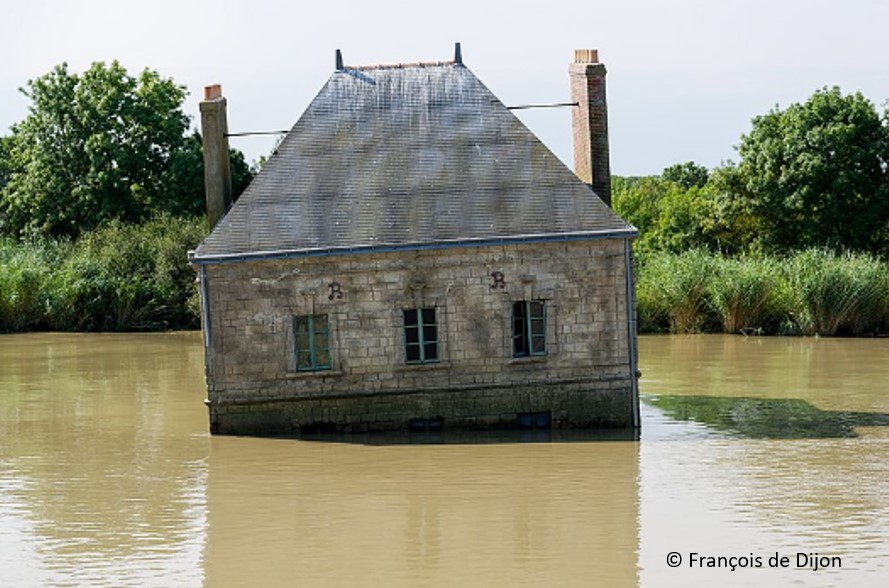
left=612, top=88, right=889, bottom=336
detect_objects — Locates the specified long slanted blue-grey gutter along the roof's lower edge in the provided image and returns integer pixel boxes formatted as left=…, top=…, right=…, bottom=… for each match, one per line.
left=188, top=227, right=639, bottom=266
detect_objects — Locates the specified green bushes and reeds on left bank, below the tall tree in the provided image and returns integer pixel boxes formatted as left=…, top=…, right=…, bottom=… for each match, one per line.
left=0, top=216, right=206, bottom=331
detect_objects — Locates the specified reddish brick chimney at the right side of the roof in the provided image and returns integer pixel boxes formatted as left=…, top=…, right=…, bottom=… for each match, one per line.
left=568, top=49, right=611, bottom=206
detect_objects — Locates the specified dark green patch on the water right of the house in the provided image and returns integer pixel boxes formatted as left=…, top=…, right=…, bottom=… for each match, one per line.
left=643, top=395, right=889, bottom=439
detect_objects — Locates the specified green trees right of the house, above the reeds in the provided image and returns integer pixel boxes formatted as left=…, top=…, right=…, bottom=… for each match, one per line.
left=612, top=88, right=889, bottom=254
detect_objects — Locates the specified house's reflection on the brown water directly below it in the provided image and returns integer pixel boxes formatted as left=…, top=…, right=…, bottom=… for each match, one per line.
left=202, top=438, right=640, bottom=587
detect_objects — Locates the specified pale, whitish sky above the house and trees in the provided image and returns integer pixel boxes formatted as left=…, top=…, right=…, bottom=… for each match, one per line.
left=0, top=0, right=889, bottom=175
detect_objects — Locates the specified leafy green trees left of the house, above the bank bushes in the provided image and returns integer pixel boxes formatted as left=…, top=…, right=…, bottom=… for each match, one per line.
left=0, top=61, right=250, bottom=237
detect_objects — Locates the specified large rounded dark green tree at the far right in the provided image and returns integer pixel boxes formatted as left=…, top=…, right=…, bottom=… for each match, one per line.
left=733, top=88, right=889, bottom=251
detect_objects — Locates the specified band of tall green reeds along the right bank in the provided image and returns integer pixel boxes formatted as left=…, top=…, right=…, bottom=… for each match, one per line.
left=636, top=249, right=889, bottom=336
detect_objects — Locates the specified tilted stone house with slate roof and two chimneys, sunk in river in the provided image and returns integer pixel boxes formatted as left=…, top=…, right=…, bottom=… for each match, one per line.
left=189, top=44, right=639, bottom=435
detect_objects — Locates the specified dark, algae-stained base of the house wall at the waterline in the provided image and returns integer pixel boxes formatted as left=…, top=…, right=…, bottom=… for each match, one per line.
left=210, top=380, right=634, bottom=435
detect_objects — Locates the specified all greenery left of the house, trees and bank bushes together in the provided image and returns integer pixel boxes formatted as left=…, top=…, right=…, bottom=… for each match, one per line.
left=0, top=62, right=248, bottom=331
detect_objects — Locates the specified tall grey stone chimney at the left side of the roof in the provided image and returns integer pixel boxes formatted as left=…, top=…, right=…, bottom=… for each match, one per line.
left=200, top=84, right=232, bottom=230
